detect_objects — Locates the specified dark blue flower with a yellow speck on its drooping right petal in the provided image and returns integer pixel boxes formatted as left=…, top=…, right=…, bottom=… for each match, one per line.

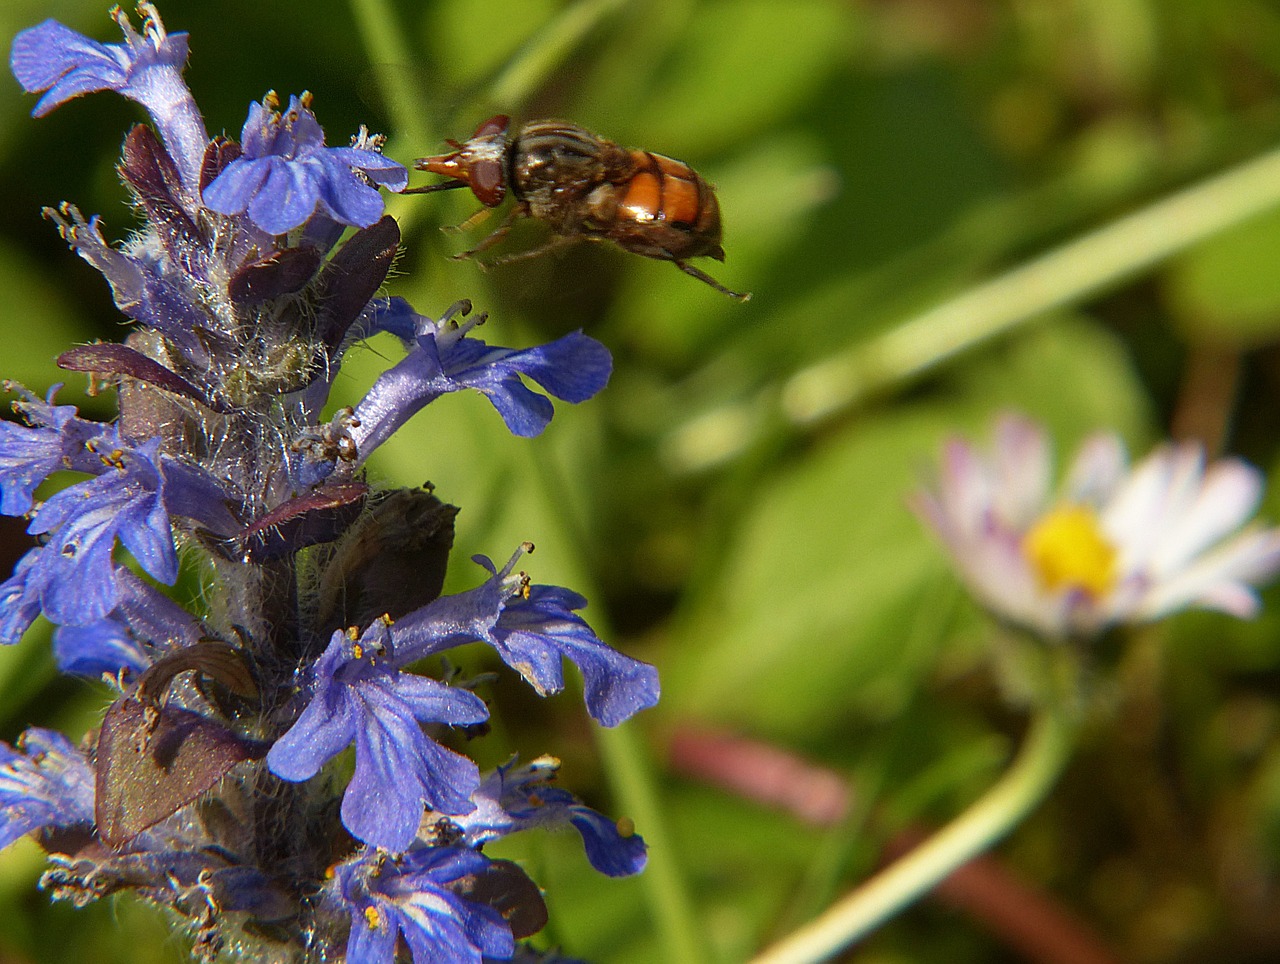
left=444, top=757, right=648, bottom=877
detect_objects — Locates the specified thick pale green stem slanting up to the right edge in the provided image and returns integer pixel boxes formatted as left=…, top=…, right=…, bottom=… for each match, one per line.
left=782, top=142, right=1280, bottom=424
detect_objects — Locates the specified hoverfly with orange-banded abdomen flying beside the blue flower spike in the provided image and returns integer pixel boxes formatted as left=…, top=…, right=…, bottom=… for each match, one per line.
left=404, top=114, right=750, bottom=301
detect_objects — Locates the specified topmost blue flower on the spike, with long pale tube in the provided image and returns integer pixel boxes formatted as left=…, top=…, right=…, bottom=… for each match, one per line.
left=9, top=3, right=209, bottom=192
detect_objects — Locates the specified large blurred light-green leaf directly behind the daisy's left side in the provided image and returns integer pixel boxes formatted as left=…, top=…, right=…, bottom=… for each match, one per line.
left=663, top=320, right=1146, bottom=737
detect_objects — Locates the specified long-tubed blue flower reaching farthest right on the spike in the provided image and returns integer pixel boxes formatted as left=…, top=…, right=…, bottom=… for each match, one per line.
left=392, top=543, right=659, bottom=726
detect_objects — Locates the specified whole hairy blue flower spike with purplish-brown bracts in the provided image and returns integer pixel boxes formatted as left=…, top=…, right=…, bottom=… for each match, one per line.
left=0, top=3, right=658, bottom=964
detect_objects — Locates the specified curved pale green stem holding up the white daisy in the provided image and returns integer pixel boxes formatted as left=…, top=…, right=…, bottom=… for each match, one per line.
left=751, top=708, right=1076, bottom=964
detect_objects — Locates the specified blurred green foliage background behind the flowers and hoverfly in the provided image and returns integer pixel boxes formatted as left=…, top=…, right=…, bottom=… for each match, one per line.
left=0, top=0, right=1280, bottom=964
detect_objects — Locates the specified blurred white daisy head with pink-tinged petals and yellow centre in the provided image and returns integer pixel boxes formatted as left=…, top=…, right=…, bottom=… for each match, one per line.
left=913, top=416, right=1280, bottom=638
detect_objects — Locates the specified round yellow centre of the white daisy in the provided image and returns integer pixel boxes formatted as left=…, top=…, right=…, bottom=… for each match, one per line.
left=1023, top=506, right=1116, bottom=599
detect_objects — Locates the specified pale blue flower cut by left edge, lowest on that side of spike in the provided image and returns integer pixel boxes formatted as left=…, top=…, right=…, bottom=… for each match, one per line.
left=0, top=726, right=93, bottom=848
